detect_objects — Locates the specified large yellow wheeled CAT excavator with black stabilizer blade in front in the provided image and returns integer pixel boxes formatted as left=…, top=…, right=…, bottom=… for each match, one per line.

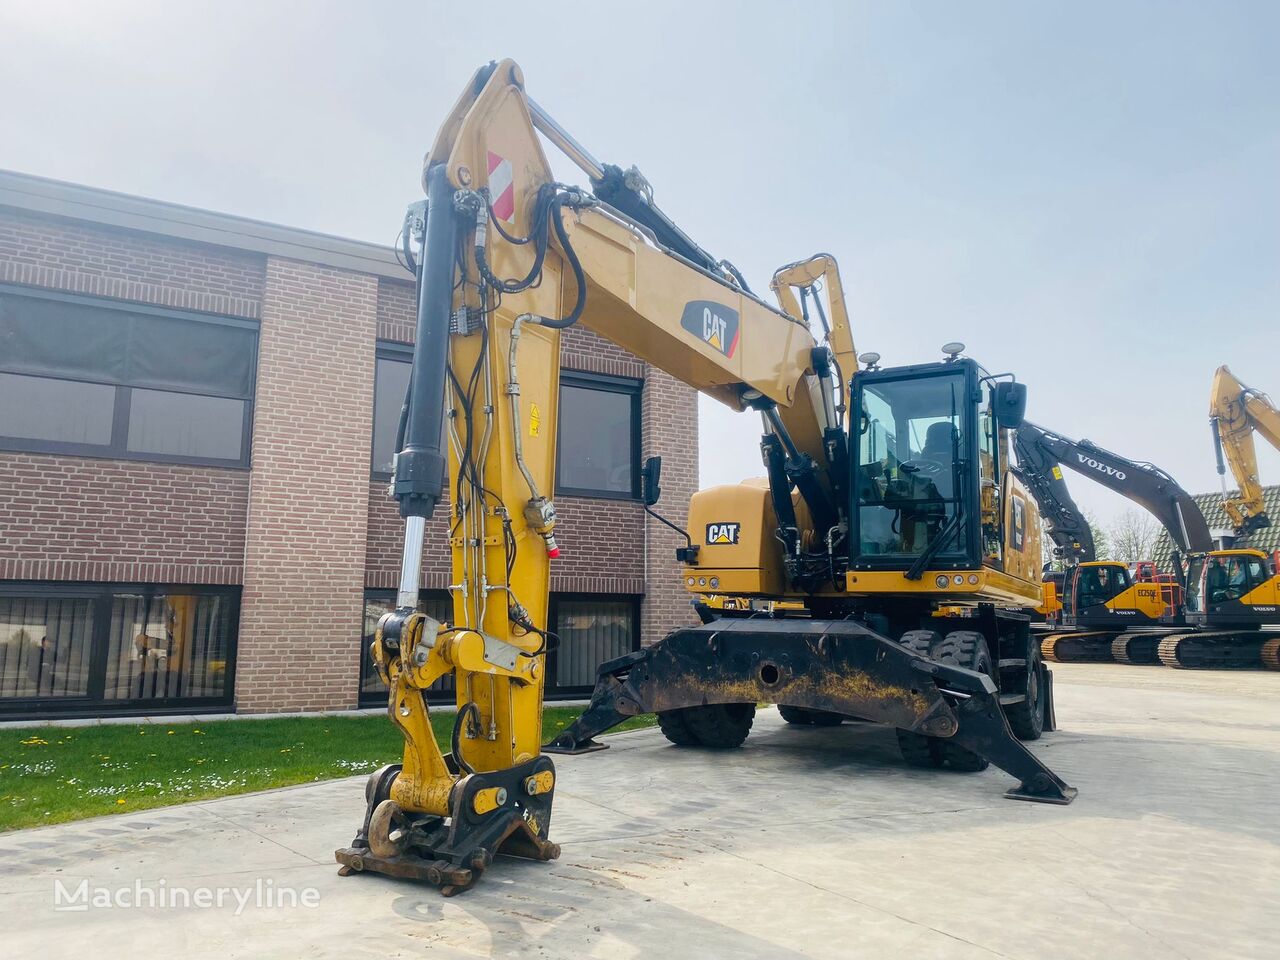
left=337, top=60, right=1075, bottom=895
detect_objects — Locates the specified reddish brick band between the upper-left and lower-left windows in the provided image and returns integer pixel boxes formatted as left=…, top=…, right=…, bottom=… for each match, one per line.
left=0, top=453, right=248, bottom=584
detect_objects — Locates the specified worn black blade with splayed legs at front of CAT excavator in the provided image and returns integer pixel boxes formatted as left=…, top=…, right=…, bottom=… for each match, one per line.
left=543, top=618, right=1076, bottom=804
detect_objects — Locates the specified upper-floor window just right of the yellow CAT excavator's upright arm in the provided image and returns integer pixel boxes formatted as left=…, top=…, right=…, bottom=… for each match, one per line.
left=556, top=371, right=641, bottom=499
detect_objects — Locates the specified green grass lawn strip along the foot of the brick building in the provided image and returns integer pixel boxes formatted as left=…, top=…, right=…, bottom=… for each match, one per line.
left=0, top=707, right=654, bottom=831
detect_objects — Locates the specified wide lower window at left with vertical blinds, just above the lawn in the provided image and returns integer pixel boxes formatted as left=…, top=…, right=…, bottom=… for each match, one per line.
left=0, top=584, right=239, bottom=716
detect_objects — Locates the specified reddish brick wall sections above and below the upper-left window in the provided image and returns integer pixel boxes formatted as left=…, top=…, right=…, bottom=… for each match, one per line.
left=0, top=209, right=264, bottom=584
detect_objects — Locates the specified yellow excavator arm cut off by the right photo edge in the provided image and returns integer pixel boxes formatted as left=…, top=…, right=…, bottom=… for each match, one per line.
left=1208, top=366, right=1280, bottom=535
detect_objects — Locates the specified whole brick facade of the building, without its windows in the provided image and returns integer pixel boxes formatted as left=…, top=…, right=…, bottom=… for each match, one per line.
left=0, top=209, right=696, bottom=712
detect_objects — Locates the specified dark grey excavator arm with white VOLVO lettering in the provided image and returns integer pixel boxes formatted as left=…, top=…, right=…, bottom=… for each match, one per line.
left=1014, top=421, right=1213, bottom=559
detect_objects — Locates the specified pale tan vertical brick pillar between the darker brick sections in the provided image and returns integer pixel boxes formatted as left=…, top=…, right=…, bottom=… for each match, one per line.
left=236, top=257, right=378, bottom=713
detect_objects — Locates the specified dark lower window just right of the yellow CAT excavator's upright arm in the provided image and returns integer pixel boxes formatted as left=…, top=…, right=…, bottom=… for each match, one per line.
left=547, top=594, right=640, bottom=696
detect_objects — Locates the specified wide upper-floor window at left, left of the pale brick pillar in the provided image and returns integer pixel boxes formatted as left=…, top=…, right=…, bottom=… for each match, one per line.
left=0, top=285, right=257, bottom=466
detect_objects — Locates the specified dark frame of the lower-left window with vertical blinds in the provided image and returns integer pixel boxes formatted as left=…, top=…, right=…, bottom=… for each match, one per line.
left=0, top=580, right=243, bottom=721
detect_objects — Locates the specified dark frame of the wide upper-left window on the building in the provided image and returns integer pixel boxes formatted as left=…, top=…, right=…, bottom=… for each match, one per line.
left=0, top=283, right=261, bottom=470
